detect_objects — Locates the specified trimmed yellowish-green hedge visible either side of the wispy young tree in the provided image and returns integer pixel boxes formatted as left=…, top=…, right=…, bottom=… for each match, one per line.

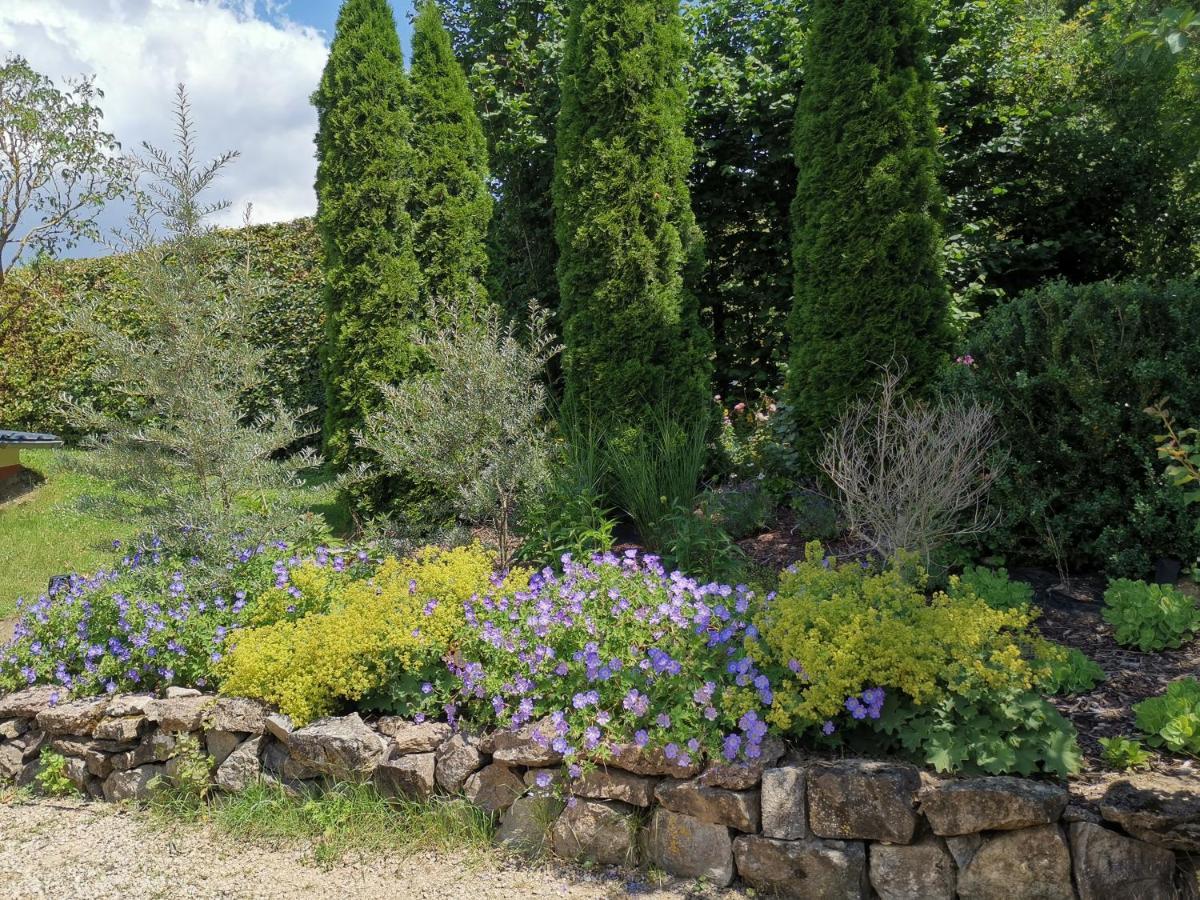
left=0, top=218, right=324, bottom=442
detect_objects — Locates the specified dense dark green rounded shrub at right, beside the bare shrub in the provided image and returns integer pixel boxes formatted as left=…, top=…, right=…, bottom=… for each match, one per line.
left=953, top=281, right=1200, bottom=577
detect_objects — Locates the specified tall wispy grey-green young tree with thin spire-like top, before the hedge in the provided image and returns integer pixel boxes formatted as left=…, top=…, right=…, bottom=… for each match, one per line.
left=58, top=89, right=323, bottom=544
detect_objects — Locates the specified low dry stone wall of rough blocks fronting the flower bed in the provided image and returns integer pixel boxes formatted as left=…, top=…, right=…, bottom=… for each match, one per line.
left=0, top=688, right=1200, bottom=900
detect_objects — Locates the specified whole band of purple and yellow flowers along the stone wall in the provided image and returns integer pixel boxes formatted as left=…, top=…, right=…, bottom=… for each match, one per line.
left=0, top=545, right=1078, bottom=774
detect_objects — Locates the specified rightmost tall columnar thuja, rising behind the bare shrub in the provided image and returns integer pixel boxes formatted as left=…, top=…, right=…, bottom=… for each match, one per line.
left=788, top=0, right=949, bottom=466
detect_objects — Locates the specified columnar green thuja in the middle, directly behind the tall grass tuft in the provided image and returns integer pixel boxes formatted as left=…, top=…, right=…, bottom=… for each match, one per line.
left=553, top=0, right=710, bottom=433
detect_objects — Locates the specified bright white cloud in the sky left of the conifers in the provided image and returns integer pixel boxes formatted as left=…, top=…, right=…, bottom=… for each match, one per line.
left=0, top=0, right=328, bottom=234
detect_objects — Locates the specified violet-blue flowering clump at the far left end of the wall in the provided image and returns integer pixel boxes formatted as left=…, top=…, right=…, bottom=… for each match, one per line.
left=0, top=539, right=321, bottom=700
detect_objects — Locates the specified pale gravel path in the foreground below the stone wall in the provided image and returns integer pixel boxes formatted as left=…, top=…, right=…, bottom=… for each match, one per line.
left=0, top=800, right=745, bottom=900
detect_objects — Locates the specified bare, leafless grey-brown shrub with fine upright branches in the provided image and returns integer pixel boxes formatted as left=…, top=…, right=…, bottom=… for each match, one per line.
left=820, top=367, right=1003, bottom=564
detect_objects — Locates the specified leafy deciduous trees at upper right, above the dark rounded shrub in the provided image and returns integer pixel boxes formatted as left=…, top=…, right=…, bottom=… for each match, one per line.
left=931, top=0, right=1200, bottom=313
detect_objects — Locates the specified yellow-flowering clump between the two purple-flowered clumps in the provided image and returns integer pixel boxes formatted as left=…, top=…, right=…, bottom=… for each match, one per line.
left=220, top=545, right=501, bottom=724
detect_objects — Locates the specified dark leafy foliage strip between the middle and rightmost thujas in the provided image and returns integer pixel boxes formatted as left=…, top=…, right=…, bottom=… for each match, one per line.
left=683, top=0, right=805, bottom=402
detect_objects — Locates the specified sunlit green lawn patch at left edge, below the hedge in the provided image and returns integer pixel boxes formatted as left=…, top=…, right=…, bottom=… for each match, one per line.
left=0, top=450, right=140, bottom=619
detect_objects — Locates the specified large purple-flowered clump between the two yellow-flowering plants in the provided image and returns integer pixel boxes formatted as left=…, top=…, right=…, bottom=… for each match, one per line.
left=455, top=550, right=774, bottom=774
